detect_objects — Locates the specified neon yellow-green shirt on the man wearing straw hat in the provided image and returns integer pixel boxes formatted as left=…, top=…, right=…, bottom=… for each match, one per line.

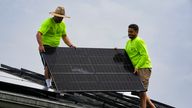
left=38, top=18, right=66, bottom=47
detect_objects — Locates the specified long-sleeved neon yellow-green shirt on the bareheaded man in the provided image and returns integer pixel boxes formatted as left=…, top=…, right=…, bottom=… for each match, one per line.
left=125, top=36, right=152, bottom=69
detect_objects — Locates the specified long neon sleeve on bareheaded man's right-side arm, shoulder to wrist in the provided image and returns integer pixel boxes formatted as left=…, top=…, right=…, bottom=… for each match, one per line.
left=135, top=40, right=148, bottom=68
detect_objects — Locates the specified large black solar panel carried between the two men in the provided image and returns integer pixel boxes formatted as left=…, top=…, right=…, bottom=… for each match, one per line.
left=43, top=47, right=144, bottom=92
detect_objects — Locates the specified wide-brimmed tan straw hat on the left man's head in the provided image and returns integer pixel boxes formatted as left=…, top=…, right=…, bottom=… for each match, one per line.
left=49, top=6, right=70, bottom=18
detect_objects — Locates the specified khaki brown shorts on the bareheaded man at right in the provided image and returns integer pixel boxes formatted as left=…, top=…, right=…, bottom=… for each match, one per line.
left=137, top=68, right=151, bottom=91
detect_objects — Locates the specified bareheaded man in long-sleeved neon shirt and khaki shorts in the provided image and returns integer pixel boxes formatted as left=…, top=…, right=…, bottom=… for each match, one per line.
left=125, top=24, right=155, bottom=108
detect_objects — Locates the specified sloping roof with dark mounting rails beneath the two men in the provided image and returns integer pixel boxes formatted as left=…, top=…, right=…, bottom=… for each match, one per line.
left=0, top=64, right=174, bottom=108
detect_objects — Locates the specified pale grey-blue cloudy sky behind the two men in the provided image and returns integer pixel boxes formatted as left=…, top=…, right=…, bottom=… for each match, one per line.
left=0, top=0, right=192, bottom=108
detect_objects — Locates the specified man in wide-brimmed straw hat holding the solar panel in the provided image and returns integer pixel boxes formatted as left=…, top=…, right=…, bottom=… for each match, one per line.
left=36, top=6, right=75, bottom=88
